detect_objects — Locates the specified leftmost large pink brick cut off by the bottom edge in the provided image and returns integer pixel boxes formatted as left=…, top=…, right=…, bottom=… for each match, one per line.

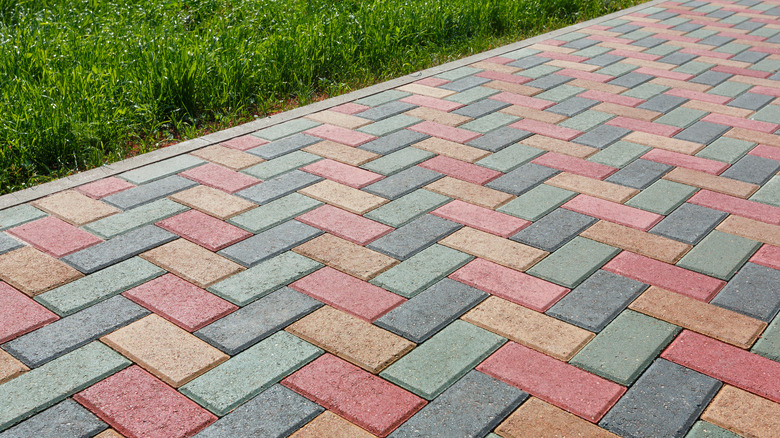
left=73, top=365, right=217, bottom=438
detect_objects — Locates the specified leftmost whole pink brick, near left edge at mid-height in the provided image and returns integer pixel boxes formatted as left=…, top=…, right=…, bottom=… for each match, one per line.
left=7, top=216, right=103, bottom=258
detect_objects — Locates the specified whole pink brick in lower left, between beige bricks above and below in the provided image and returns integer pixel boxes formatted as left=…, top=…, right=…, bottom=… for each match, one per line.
left=122, top=274, right=238, bottom=332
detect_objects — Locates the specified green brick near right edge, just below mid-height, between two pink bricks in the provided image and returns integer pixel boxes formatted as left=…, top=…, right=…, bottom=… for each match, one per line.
left=677, top=230, right=761, bottom=280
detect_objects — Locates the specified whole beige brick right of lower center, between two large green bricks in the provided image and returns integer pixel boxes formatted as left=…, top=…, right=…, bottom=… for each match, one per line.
left=461, top=296, right=596, bottom=361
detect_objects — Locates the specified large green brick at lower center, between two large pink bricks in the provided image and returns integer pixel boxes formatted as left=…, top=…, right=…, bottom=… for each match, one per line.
left=379, top=320, right=506, bottom=400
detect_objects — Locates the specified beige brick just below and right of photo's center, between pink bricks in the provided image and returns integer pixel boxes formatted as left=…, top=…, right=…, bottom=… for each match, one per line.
left=439, top=227, right=549, bottom=271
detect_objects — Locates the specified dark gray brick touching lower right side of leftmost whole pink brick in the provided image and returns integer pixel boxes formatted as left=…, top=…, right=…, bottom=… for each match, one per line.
left=62, top=225, right=179, bottom=274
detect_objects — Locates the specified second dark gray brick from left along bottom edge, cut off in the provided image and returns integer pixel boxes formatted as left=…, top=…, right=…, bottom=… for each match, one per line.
left=195, top=385, right=325, bottom=438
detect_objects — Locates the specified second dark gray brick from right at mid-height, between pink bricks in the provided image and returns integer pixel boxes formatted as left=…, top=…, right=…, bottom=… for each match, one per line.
left=511, top=208, right=596, bottom=252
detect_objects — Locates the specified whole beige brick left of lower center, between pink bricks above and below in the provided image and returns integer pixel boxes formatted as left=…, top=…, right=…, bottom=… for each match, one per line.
left=285, top=306, right=415, bottom=374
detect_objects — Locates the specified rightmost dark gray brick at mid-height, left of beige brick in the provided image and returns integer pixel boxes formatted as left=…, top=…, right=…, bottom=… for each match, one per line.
left=650, top=202, right=728, bottom=245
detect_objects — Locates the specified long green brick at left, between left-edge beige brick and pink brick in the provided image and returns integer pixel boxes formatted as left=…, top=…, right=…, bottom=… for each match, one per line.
left=35, top=257, right=165, bottom=316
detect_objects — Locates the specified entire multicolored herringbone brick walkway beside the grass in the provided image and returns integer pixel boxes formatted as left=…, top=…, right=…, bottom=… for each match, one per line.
left=0, top=0, right=780, bottom=438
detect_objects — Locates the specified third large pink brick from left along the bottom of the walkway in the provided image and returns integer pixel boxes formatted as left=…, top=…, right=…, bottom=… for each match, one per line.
left=477, top=341, right=626, bottom=423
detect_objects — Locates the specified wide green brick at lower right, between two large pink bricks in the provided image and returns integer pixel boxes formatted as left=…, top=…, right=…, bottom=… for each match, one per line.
left=569, top=310, right=680, bottom=386
